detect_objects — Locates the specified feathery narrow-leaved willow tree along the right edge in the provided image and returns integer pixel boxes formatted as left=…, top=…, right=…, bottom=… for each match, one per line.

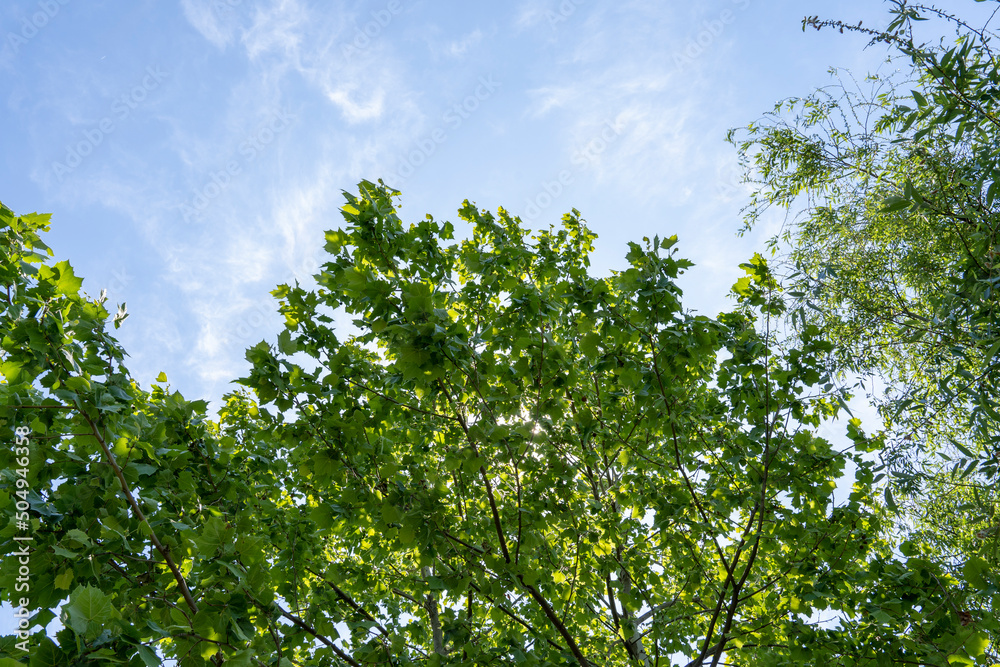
left=732, top=0, right=1000, bottom=656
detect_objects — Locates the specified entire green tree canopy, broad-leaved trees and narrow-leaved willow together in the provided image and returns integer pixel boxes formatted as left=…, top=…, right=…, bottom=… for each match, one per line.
left=0, top=2, right=1000, bottom=667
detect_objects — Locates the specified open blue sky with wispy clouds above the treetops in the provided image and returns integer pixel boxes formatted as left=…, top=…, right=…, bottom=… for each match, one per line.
left=0, top=0, right=952, bottom=405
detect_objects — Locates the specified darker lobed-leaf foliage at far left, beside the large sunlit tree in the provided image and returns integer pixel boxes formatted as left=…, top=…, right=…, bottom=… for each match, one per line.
left=0, top=201, right=271, bottom=665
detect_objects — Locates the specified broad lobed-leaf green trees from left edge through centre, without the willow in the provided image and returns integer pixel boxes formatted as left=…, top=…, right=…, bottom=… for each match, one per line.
left=0, top=182, right=986, bottom=667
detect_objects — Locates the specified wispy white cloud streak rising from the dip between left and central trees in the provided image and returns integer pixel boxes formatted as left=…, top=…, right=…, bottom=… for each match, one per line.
left=133, top=0, right=426, bottom=395
